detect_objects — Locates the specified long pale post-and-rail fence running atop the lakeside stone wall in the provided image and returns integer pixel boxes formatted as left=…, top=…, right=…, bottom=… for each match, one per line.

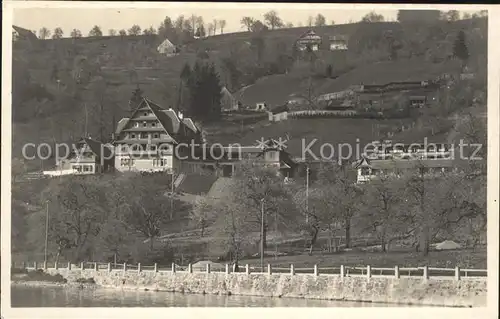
left=12, top=262, right=488, bottom=280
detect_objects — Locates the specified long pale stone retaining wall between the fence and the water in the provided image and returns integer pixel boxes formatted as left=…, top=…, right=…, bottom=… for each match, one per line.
left=47, top=269, right=487, bottom=307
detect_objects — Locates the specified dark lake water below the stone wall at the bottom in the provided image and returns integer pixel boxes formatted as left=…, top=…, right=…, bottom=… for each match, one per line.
left=11, top=286, right=394, bottom=307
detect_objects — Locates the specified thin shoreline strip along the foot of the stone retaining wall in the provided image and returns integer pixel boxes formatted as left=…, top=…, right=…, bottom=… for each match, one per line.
left=7, top=280, right=466, bottom=308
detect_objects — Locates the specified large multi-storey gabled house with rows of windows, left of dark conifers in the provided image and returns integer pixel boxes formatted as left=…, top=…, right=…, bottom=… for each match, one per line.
left=115, top=98, right=202, bottom=172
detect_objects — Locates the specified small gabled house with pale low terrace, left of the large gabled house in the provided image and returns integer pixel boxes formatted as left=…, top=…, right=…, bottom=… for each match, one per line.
left=43, top=137, right=114, bottom=176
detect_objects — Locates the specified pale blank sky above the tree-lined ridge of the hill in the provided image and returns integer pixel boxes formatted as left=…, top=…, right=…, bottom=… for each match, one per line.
left=13, top=2, right=404, bottom=36
